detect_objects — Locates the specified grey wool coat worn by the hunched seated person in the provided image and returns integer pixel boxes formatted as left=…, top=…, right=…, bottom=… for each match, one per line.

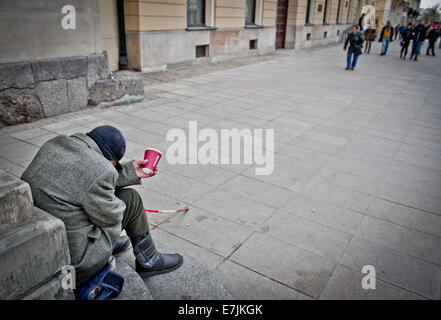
left=22, top=133, right=141, bottom=282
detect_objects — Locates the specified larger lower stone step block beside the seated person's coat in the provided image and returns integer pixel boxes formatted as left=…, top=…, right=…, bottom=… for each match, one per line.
left=0, top=208, right=73, bottom=299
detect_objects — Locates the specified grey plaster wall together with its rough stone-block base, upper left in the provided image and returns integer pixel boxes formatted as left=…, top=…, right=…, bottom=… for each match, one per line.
left=0, top=0, right=115, bottom=125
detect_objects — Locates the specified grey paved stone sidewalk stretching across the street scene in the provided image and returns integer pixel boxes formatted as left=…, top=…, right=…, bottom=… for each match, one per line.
left=0, top=41, right=441, bottom=299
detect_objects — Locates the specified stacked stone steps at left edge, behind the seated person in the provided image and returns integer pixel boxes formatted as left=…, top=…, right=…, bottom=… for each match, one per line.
left=0, top=170, right=74, bottom=299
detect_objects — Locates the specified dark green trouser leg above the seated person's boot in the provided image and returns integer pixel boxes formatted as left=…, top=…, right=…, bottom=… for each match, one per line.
left=115, top=188, right=149, bottom=238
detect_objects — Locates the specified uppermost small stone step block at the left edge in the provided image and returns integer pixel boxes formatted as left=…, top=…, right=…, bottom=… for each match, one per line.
left=0, top=170, right=34, bottom=238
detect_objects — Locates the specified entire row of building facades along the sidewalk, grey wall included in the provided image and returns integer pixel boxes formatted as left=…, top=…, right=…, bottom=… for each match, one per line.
left=0, top=0, right=419, bottom=125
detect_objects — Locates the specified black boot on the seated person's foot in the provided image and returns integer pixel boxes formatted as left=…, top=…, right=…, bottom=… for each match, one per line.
left=130, top=233, right=184, bottom=278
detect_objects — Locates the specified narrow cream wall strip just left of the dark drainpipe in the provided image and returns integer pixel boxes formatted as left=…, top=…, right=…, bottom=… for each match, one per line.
left=100, top=0, right=119, bottom=71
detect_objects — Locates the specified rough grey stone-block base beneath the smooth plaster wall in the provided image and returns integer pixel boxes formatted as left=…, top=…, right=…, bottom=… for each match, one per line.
left=0, top=54, right=109, bottom=125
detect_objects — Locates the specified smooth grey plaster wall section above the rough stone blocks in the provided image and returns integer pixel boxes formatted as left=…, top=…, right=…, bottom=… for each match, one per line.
left=0, top=0, right=103, bottom=63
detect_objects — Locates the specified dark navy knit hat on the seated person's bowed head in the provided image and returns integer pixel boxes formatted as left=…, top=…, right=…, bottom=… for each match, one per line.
left=86, top=126, right=126, bottom=170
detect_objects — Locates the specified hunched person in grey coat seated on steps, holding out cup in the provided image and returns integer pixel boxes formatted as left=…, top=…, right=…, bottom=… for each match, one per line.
left=22, top=126, right=183, bottom=288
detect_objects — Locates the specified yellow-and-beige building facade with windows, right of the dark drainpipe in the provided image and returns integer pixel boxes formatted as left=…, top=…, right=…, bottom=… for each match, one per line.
left=115, top=0, right=363, bottom=71
